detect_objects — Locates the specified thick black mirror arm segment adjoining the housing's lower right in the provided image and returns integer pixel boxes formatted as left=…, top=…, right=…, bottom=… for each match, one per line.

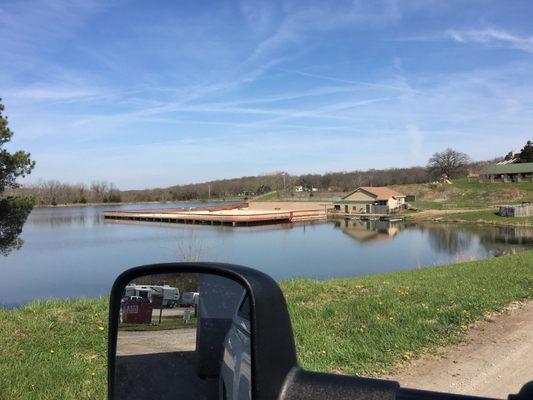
left=279, top=367, right=399, bottom=400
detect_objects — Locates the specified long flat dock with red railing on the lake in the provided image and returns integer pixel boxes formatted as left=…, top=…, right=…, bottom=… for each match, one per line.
left=104, top=203, right=327, bottom=226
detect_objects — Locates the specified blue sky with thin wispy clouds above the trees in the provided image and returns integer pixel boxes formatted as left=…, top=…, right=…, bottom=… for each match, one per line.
left=0, top=0, right=533, bottom=189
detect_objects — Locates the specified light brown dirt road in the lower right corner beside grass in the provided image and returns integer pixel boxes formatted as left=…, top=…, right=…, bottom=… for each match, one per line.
left=387, top=301, right=533, bottom=398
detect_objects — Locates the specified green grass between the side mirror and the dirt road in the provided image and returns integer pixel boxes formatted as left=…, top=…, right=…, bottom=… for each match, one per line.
left=281, top=251, right=533, bottom=375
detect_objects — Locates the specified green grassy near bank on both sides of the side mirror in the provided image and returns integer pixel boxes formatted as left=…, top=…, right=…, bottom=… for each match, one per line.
left=0, top=251, right=533, bottom=399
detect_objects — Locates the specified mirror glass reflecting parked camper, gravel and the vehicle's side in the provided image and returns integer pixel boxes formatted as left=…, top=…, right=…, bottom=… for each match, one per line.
left=114, top=273, right=252, bottom=400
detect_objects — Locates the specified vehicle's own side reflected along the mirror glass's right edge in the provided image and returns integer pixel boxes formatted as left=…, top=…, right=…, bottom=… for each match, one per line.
left=219, top=294, right=252, bottom=400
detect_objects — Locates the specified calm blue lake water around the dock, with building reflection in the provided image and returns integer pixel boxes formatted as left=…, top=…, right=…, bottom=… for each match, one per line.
left=0, top=203, right=533, bottom=307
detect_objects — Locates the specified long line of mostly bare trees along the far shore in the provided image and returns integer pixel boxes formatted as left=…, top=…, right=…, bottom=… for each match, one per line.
left=13, top=149, right=489, bottom=205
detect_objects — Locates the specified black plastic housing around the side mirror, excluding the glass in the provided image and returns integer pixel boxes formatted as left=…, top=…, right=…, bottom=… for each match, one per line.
left=108, top=263, right=297, bottom=400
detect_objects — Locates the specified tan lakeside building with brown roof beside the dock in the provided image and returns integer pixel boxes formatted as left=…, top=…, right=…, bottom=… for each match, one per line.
left=334, top=187, right=405, bottom=214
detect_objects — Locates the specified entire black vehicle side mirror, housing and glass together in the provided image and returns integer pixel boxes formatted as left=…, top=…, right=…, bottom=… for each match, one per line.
left=108, top=263, right=296, bottom=400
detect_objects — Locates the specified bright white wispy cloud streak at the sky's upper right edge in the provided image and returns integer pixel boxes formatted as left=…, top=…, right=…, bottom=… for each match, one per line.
left=446, top=28, right=533, bottom=53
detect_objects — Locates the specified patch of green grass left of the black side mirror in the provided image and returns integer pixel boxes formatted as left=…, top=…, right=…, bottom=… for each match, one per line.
left=0, top=299, right=108, bottom=400
